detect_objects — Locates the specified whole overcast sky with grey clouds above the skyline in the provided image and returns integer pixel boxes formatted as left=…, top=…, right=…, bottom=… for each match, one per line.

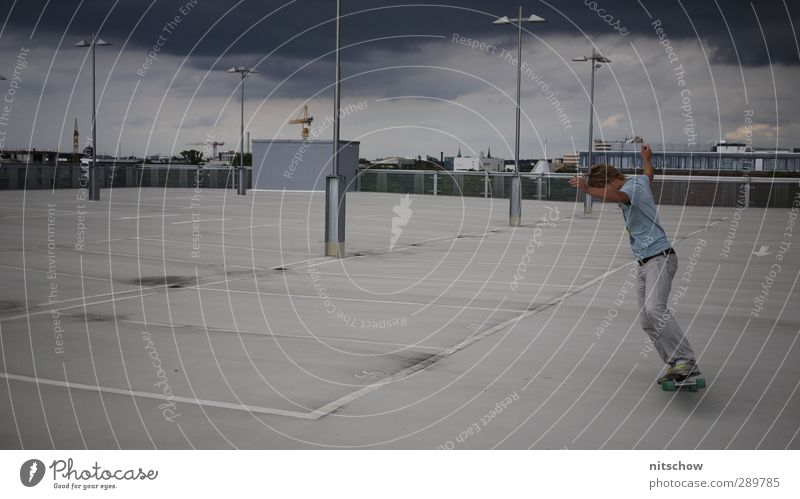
left=0, top=0, right=800, bottom=158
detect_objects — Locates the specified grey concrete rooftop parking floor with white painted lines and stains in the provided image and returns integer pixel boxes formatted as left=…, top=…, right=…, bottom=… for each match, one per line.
left=0, top=189, right=800, bottom=449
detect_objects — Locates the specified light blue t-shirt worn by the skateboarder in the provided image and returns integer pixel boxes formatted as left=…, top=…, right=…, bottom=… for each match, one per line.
left=618, top=175, right=671, bottom=260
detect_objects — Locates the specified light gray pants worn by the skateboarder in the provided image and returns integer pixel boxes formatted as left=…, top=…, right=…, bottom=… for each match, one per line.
left=636, top=254, right=696, bottom=364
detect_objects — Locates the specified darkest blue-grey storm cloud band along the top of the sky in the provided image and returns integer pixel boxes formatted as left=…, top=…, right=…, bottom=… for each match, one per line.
left=3, top=0, right=800, bottom=66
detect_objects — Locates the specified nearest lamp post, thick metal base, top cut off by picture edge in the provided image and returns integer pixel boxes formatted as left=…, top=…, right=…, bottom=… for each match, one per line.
left=325, top=0, right=346, bottom=258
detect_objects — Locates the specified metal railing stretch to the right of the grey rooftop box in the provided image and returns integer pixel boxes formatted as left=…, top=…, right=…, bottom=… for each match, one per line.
left=356, top=169, right=800, bottom=208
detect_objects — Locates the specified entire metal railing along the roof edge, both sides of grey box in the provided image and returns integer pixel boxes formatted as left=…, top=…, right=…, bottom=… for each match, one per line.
left=0, top=162, right=800, bottom=208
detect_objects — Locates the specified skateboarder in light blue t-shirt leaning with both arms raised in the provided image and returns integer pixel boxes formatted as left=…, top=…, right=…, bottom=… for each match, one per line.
left=569, top=145, right=700, bottom=386
